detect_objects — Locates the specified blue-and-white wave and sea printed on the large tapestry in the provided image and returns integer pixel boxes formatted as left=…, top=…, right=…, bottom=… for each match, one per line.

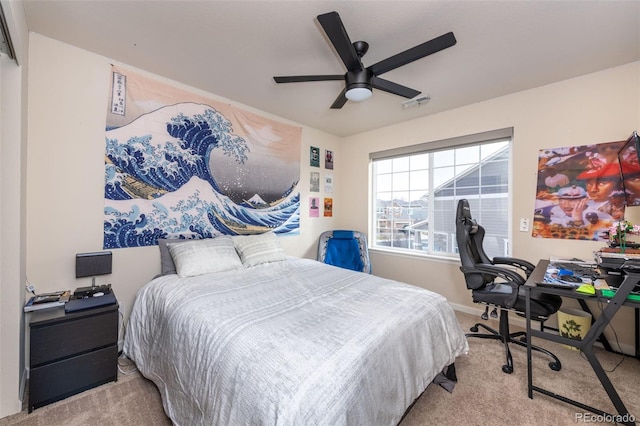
left=104, top=103, right=300, bottom=249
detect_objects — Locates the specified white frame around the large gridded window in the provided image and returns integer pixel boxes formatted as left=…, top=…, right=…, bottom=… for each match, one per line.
left=368, top=127, right=513, bottom=261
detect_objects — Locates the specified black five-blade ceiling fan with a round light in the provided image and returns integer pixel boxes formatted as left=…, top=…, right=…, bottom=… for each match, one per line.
left=273, top=12, right=456, bottom=109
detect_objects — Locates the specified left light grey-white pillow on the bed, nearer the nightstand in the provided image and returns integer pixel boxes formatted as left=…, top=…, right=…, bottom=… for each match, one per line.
left=167, top=236, right=242, bottom=278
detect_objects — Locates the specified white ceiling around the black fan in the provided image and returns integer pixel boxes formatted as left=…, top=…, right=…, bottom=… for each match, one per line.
left=24, top=0, right=640, bottom=136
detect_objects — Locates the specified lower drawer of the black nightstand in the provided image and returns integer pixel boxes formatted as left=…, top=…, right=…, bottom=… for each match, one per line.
left=29, top=345, right=118, bottom=410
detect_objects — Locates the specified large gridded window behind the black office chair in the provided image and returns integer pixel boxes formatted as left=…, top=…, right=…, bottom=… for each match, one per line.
left=370, top=128, right=513, bottom=257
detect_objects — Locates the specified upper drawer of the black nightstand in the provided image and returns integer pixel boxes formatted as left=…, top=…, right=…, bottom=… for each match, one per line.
left=30, top=309, right=118, bottom=368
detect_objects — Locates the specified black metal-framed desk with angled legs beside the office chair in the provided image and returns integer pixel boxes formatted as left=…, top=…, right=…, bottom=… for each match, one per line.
left=524, top=260, right=640, bottom=425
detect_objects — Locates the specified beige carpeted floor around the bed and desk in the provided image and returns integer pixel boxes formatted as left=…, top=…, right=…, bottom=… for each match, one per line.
left=0, top=313, right=640, bottom=426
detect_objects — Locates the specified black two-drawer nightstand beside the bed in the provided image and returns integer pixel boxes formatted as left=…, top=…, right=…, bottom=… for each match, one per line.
left=29, top=294, right=118, bottom=412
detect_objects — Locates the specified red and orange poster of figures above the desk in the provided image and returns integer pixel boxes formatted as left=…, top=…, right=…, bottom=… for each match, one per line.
left=532, top=141, right=625, bottom=241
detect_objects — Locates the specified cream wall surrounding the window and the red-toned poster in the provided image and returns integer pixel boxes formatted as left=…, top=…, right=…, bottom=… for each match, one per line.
left=339, top=59, right=640, bottom=352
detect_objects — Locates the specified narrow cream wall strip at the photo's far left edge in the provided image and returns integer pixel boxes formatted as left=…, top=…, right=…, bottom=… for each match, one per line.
left=0, top=1, right=28, bottom=418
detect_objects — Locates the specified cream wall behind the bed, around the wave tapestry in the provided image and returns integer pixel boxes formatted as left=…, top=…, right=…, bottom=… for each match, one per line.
left=27, top=33, right=340, bottom=352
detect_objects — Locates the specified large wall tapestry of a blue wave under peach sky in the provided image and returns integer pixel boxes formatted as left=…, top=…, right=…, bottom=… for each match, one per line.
left=104, top=67, right=302, bottom=249
